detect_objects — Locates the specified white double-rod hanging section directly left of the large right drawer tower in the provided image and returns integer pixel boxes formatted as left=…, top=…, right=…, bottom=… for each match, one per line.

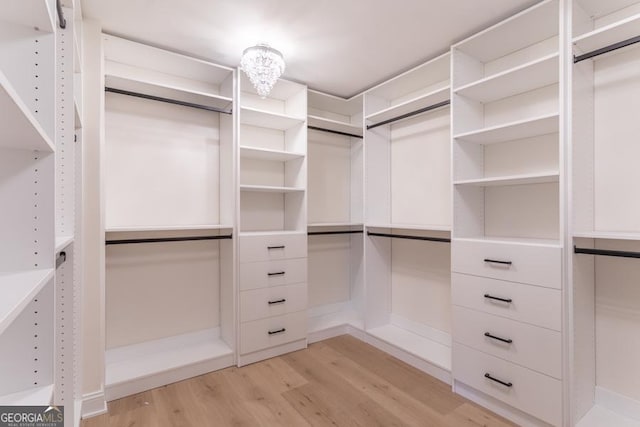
left=364, top=54, right=451, bottom=382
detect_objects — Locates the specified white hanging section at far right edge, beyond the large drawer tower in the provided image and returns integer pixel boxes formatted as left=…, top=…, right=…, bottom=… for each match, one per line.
left=569, top=0, right=640, bottom=427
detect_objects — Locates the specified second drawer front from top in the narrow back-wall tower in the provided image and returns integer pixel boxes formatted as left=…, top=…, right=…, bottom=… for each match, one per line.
left=238, top=258, right=307, bottom=291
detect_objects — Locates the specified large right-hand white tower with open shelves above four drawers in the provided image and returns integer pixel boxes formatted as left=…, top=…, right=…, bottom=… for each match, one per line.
left=451, top=0, right=564, bottom=425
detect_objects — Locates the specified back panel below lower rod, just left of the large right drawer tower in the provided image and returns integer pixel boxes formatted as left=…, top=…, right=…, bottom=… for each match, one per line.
left=391, top=239, right=451, bottom=333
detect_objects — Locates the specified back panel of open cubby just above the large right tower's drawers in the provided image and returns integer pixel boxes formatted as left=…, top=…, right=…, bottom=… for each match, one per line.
left=485, top=182, right=560, bottom=239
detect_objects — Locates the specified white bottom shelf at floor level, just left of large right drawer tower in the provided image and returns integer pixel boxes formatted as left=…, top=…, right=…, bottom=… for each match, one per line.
left=366, top=325, right=451, bottom=372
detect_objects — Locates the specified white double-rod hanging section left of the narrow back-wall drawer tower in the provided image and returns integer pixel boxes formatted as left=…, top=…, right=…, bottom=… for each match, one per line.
left=103, top=35, right=236, bottom=400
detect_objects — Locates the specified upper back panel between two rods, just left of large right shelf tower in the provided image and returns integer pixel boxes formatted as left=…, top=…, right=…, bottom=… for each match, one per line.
left=391, top=108, right=451, bottom=225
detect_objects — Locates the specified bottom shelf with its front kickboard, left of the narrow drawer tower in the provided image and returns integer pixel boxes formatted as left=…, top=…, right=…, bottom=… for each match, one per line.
left=106, top=328, right=234, bottom=401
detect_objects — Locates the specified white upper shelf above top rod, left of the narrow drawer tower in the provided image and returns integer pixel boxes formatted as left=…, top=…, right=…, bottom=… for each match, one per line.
left=105, top=74, right=233, bottom=111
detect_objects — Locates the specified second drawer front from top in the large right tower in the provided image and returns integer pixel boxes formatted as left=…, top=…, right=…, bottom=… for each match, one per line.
left=451, top=273, right=562, bottom=331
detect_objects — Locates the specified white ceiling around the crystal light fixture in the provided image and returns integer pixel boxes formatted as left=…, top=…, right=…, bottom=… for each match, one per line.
left=82, top=0, right=539, bottom=97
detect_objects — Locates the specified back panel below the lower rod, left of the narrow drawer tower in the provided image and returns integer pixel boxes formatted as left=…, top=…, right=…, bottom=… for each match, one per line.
left=105, top=241, right=220, bottom=348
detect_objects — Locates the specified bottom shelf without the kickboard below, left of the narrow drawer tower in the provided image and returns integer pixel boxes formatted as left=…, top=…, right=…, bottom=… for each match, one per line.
left=106, top=330, right=233, bottom=387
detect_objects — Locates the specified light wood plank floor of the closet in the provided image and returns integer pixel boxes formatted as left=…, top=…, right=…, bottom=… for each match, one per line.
left=82, top=335, right=513, bottom=427
